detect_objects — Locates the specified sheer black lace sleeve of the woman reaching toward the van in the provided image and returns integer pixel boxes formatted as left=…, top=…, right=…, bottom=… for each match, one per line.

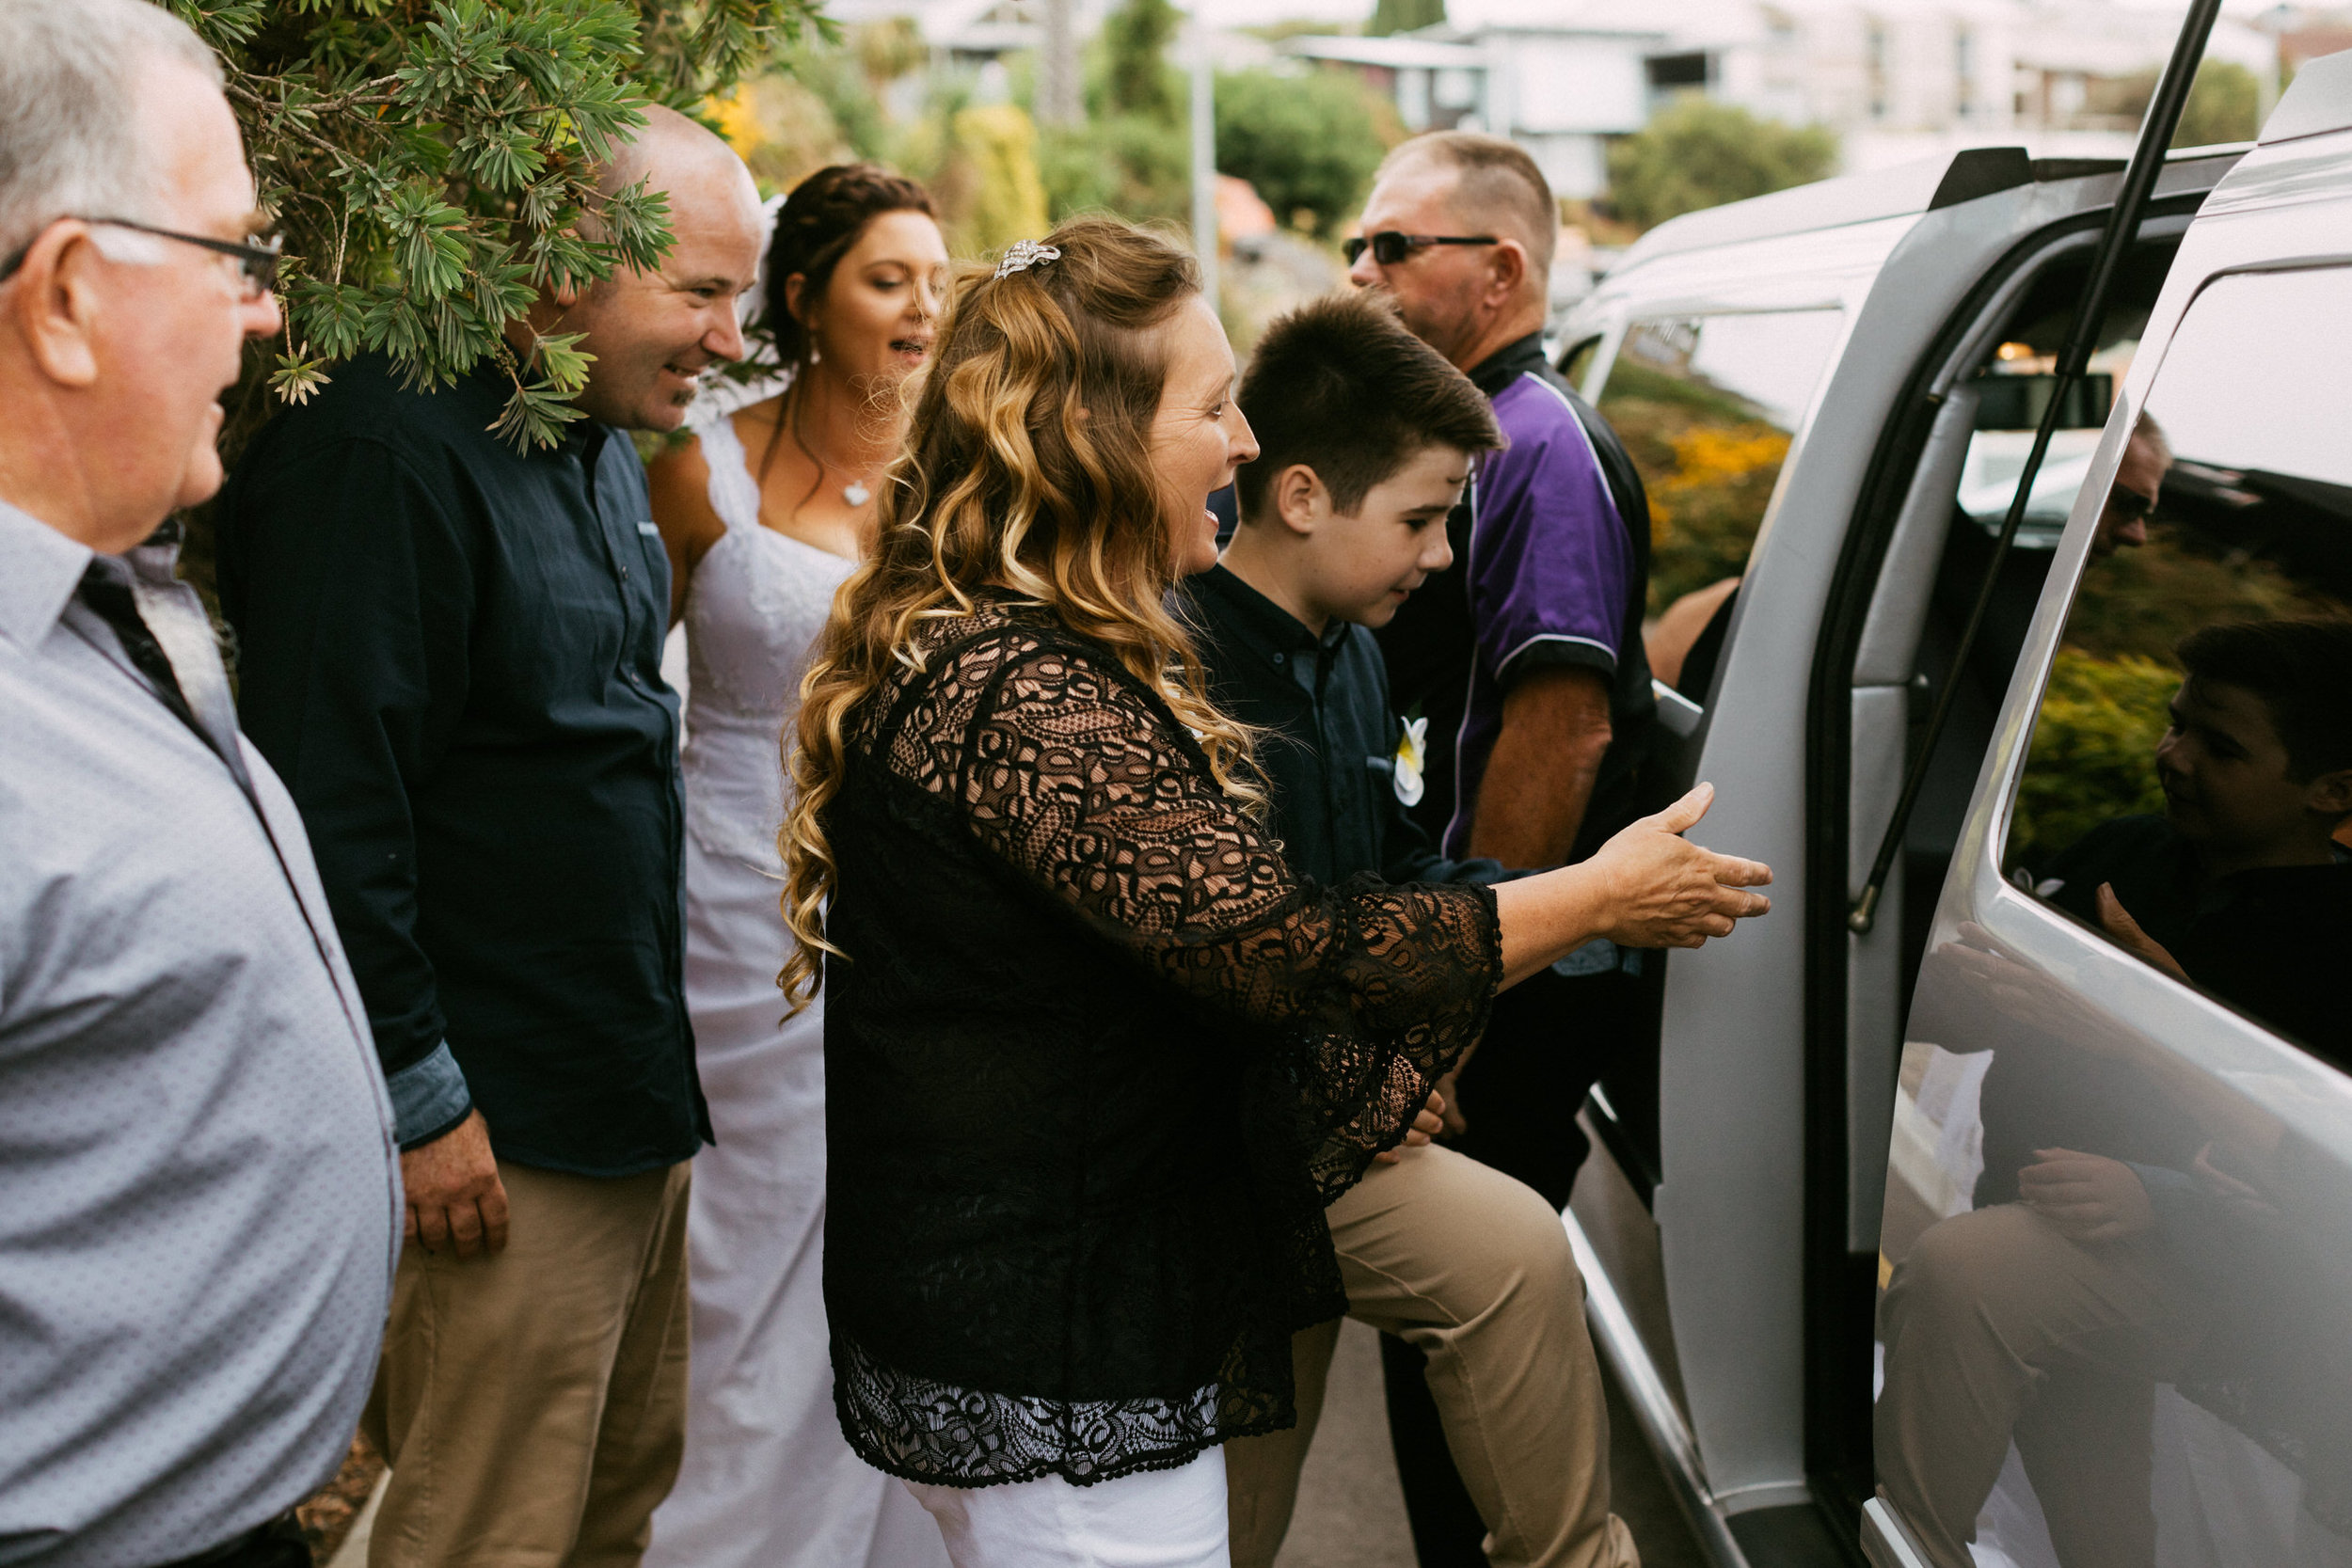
left=894, top=637, right=1501, bottom=1195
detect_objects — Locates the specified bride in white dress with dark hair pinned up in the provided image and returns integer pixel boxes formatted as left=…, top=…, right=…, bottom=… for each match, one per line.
left=644, top=165, right=948, bottom=1568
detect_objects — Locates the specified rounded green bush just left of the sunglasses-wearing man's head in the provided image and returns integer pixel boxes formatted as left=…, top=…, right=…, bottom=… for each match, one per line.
left=1216, top=71, right=1388, bottom=232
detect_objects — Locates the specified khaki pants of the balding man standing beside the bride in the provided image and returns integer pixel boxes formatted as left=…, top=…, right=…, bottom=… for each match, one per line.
left=362, top=1159, right=690, bottom=1568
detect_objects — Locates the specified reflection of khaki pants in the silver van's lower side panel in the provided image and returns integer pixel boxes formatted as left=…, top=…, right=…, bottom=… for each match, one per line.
left=1872, top=1204, right=2206, bottom=1568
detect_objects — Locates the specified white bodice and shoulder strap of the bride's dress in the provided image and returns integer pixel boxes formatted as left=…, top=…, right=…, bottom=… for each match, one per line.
left=685, top=411, right=854, bottom=872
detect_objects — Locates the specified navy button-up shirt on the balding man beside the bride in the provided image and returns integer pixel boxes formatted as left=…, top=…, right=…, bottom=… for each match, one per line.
left=221, top=357, right=706, bottom=1176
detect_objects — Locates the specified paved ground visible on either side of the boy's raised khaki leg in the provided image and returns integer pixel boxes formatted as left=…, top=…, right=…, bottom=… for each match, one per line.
left=1278, top=1323, right=1706, bottom=1568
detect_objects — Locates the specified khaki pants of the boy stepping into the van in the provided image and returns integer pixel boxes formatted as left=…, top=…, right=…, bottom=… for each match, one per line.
left=1226, top=1145, right=1640, bottom=1568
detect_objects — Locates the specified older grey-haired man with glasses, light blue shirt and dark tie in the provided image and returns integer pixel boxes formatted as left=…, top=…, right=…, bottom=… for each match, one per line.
left=0, top=0, right=403, bottom=1568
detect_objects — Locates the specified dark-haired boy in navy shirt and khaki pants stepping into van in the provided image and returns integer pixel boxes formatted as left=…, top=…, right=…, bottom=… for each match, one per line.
left=1184, top=293, right=1637, bottom=1568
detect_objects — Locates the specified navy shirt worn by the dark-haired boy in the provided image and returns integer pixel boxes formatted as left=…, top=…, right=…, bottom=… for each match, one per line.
left=1176, top=566, right=1508, bottom=884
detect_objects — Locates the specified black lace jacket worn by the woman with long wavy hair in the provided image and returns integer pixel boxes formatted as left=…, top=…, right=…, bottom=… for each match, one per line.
left=826, top=607, right=1501, bottom=1486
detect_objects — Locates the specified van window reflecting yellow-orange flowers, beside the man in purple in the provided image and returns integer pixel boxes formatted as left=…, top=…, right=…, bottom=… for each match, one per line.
left=1599, top=310, right=1844, bottom=616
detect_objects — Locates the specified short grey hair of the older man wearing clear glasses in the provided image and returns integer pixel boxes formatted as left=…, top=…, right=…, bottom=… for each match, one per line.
left=0, top=0, right=221, bottom=256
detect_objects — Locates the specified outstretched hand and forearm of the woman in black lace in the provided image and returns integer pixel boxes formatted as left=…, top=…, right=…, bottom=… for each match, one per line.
left=1494, top=785, right=1772, bottom=985
